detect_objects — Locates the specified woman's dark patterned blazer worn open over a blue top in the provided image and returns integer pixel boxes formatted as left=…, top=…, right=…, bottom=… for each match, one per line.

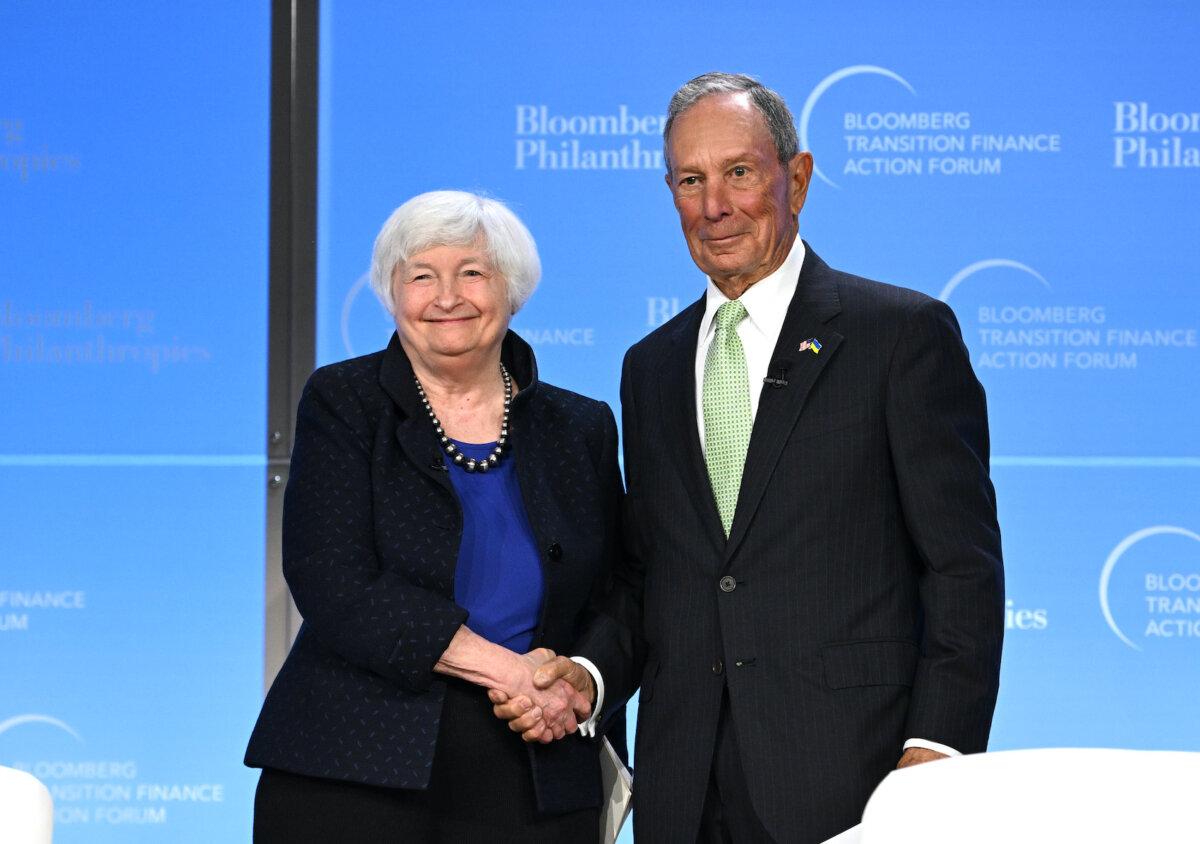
left=246, top=331, right=624, bottom=813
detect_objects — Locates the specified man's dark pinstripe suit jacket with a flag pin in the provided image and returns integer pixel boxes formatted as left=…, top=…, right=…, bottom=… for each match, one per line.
left=577, top=242, right=1003, bottom=844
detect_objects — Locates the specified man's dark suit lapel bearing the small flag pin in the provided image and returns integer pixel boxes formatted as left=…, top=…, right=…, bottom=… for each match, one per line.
left=720, top=244, right=842, bottom=563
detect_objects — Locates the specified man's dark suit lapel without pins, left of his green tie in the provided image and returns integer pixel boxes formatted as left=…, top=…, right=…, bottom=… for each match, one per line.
left=658, top=297, right=725, bottom=549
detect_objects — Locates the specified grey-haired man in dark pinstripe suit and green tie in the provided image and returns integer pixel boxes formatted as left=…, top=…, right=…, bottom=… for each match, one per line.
left=497, top=73, right=1003, bottom=843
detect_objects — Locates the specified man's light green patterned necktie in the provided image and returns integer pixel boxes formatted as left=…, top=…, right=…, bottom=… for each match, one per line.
left=703, top=299, right=752, bottom=537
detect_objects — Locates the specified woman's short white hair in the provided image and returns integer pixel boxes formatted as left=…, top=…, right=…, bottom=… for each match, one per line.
left=371, top=191, right=541, bottom=313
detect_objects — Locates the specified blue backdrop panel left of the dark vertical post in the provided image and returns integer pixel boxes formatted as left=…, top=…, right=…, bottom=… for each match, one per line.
left=0, top=2, right=270, bottom=844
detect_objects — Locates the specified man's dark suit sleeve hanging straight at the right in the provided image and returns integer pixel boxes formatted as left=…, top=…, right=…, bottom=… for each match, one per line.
left=887, top=298, right=1004, bottom=753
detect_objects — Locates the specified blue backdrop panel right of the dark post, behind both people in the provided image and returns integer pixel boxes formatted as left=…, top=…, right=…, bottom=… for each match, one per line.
left=318, top=2, right=1200, bottom=840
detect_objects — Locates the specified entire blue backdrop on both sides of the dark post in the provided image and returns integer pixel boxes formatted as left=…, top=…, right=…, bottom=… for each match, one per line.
left=0, top=0, right=1200, bottom=842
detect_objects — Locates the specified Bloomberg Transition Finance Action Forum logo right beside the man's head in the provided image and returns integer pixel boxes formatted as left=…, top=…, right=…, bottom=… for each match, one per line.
left=798, top=65, right=1062, bottom=187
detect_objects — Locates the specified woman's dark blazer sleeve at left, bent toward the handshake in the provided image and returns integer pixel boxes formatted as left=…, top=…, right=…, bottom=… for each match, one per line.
left=283, top=369, right=468, bottom=693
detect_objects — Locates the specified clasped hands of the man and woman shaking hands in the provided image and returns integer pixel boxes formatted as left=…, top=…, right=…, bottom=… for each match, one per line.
left=487, top=647, right=596, bottom=744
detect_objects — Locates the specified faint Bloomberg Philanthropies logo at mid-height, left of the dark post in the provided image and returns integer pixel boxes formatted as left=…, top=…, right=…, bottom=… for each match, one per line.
left=0, top=299, right=212, bottom=375
